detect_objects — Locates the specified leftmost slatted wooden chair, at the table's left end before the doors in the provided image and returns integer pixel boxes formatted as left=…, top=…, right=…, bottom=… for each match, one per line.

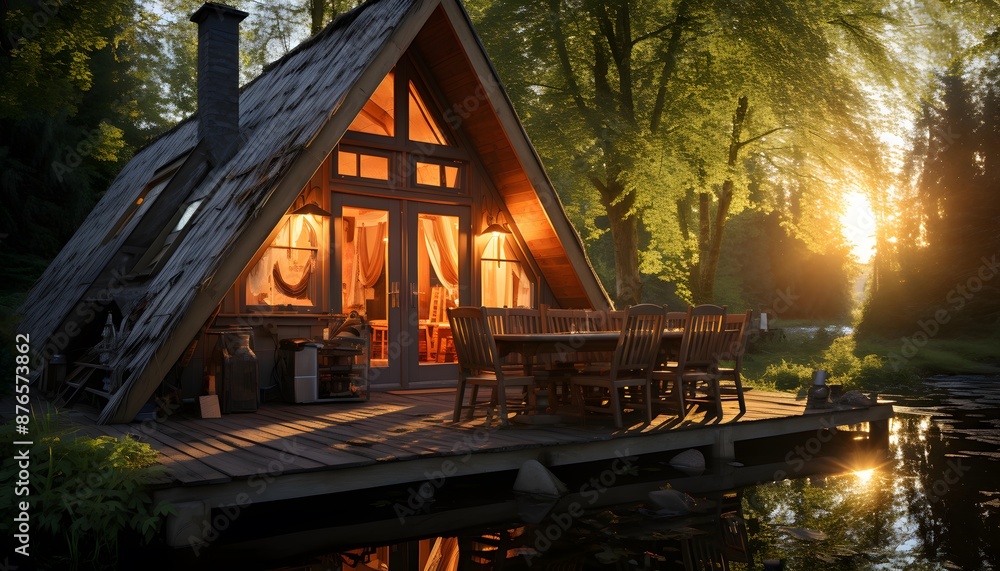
left=448, top=307, right=535, bottom=426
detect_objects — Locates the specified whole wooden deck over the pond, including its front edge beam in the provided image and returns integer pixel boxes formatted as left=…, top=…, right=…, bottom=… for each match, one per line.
left=62, top=389, right=892, bottom=505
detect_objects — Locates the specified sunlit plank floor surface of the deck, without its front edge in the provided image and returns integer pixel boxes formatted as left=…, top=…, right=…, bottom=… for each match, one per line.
left=5, top=390, right=891, bottom=498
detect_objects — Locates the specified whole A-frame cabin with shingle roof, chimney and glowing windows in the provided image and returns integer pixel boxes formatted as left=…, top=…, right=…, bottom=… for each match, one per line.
left=21, top=0, right=609, bottom=422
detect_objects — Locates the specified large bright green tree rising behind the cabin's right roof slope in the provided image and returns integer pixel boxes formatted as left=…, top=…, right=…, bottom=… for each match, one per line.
left=472, top=0, right=888, bottom=304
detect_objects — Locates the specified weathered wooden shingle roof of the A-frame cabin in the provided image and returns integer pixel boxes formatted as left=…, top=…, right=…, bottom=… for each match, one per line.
left=21, top=0, right=608, bottom=422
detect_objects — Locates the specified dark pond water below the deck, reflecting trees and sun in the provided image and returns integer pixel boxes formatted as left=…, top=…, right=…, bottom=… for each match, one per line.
left=174, top=377, right=1000, bottom=571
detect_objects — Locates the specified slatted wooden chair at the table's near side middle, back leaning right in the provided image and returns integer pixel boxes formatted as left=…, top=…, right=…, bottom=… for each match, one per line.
left=570, top=304, right=665, bottom=428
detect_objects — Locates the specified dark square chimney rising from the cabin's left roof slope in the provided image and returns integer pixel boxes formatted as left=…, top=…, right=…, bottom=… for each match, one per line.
left=191, top=2, right=248, bottom=165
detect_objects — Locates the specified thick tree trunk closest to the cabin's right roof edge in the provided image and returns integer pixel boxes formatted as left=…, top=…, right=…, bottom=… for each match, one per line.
left=597, top=181, right=642, bottom=308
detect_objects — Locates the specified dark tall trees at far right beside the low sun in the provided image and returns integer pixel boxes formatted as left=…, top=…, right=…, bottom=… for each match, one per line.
left=864, top=54, right=1000, bottom=336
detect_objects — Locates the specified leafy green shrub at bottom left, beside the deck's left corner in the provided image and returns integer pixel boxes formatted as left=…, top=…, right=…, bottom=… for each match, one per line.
left=0, top=414, right=173, bottom=568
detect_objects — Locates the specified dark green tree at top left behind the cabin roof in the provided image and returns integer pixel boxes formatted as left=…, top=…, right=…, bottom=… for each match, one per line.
left=0, top=0, right=169, bottom=291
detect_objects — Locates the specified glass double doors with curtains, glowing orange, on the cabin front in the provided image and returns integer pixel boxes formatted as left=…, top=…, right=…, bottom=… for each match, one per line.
left=331, top=193, right=470, bottom=387
